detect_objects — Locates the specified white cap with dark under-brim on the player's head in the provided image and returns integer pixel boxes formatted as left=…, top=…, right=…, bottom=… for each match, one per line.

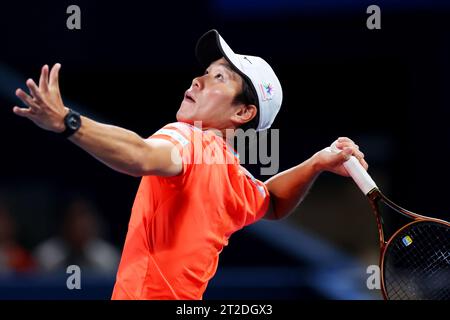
left=195, top=29, right=283, bottom=131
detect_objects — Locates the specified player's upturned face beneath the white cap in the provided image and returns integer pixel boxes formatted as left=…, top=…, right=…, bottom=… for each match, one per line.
left=177, top=58, right=242, bottom=130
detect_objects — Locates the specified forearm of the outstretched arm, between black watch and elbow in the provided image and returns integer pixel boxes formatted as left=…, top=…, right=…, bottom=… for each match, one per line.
left=69, top=117, right=150, bottom=176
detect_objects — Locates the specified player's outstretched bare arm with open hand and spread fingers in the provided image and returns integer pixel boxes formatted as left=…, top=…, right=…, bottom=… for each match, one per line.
left=14, top=64, right=182, bottom=176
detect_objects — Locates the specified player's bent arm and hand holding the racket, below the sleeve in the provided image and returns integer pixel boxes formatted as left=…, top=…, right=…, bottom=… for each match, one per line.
left=264, top=138, right=368, bottom=220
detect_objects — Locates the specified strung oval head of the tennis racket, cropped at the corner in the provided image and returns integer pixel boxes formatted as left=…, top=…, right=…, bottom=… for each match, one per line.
left=381, top=218, right=450, bottom=300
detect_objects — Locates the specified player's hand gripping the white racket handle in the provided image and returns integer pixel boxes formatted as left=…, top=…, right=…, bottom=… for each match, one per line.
left=313, top=137, right=369, bottom=177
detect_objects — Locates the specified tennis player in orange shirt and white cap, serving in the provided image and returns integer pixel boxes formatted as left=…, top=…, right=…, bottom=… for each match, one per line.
left=13, top=30, right=367, bottom=299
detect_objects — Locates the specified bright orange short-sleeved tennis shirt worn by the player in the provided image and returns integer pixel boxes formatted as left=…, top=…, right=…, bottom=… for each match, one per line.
left=112, top=122, right=270, bottom=299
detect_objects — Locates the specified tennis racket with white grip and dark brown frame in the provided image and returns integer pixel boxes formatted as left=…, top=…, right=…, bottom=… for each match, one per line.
left=329, top=145, right=450, bottom=300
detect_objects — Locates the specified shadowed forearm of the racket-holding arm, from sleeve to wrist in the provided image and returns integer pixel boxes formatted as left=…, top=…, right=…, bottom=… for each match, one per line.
left=265, top=157, right=321, bottom=219
